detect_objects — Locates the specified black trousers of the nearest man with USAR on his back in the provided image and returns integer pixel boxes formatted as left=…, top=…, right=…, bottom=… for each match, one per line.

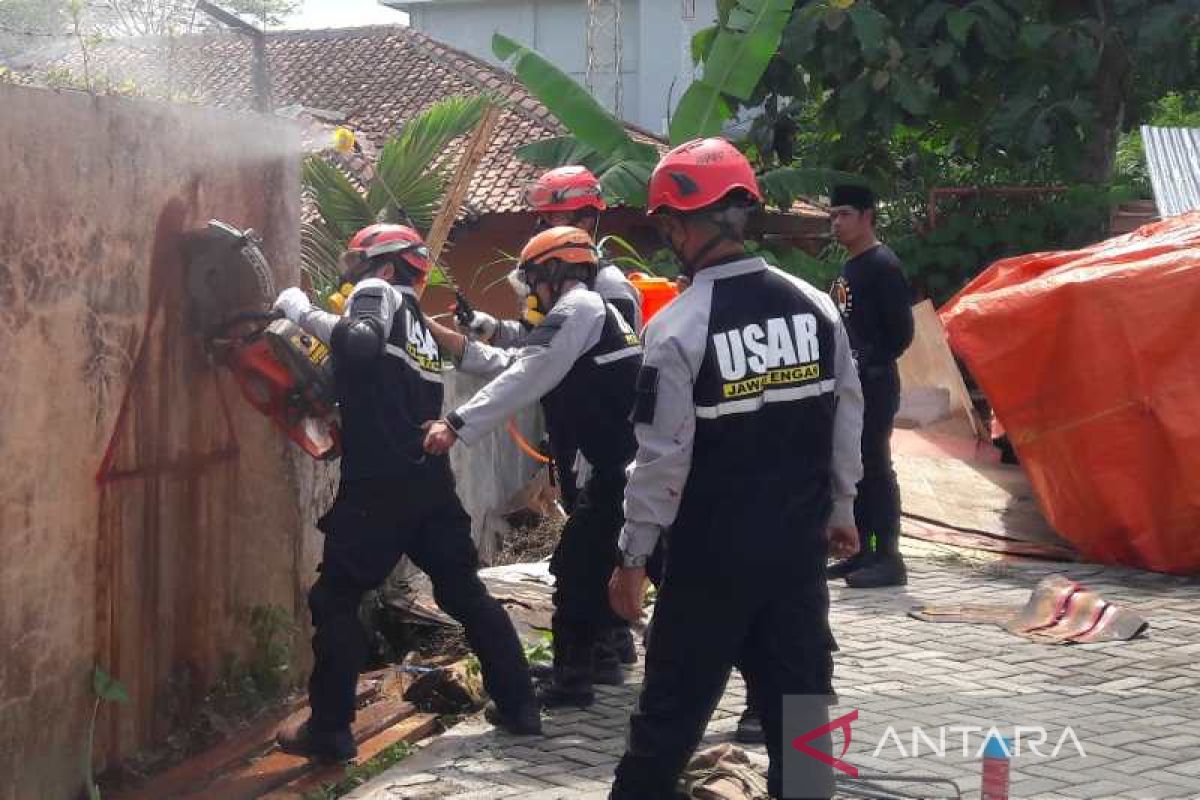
left=612, top=486, right=836, bottom=800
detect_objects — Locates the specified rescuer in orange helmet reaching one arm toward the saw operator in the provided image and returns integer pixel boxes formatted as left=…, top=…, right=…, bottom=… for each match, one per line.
left=425, top=225, right=642, bottom=708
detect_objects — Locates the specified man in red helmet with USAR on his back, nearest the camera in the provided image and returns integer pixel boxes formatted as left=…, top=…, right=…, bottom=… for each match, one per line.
left=610, top=138, right=862, bottom=800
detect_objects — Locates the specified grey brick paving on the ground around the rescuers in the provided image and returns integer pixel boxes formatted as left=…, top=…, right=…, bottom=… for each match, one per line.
left=350, top=540, right=1200, bottom=800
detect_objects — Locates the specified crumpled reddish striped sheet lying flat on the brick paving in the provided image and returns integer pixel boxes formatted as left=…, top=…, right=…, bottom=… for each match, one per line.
left=908, top=575, right=1150, bottom=644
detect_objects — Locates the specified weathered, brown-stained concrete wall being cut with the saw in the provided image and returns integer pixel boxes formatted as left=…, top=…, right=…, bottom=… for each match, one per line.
left=0, top=85, right=328, bottom=800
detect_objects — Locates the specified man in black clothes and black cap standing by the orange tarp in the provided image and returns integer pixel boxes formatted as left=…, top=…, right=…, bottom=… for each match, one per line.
left=828, top=185, right=913, bottom=589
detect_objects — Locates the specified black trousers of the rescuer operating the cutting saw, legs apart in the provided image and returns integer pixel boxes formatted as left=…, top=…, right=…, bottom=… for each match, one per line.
left=308, top=467, right=533, bottom=730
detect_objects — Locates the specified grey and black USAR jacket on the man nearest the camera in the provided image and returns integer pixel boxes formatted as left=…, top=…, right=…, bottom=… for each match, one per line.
left=620, top=258, right=863, bottom=563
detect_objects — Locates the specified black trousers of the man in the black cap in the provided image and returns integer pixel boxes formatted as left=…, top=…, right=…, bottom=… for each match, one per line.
left=854, top=363, right=900, bottom=553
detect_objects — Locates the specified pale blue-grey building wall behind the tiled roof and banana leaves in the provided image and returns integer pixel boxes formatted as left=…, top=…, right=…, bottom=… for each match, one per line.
left=403, top=0, right=716, bottom=133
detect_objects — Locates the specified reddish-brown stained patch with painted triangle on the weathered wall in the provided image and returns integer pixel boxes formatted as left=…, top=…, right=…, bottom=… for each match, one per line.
left=95, top=198, right=239, bottom=763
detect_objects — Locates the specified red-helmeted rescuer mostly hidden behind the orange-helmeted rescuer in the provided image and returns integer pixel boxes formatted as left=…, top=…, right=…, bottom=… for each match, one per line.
left=468, top=164, right=642, bottom=682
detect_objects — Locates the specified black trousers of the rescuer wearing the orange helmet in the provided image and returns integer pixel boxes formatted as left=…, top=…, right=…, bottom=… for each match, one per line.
left=550, top=469, right=625, bottom=669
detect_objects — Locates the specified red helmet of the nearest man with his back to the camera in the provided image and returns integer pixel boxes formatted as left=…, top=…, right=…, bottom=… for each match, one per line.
left=646, top=138, right=762, bottom=213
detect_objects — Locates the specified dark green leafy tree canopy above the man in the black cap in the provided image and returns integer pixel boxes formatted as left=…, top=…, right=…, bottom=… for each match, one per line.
left=746, top=0, right=1200, bottom=182
